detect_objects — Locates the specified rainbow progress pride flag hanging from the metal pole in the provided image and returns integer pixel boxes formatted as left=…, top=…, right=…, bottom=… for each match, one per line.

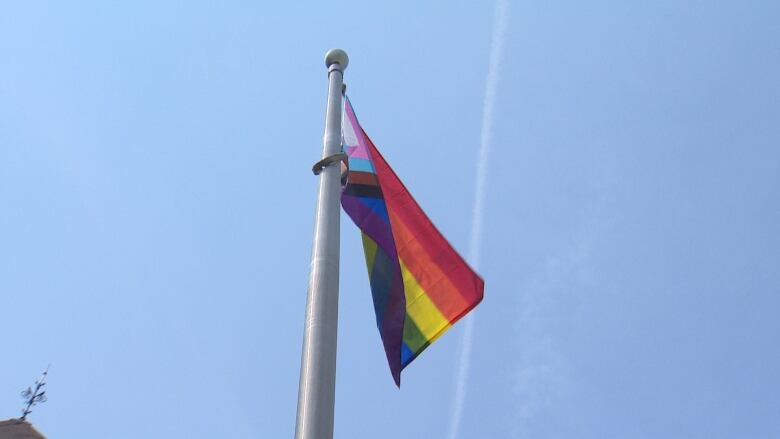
left=341, top=99, right=484, bottom=387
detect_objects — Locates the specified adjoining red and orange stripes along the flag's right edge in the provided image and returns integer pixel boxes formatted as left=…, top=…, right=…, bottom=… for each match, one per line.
left=364, top=132, right=484, bottom=322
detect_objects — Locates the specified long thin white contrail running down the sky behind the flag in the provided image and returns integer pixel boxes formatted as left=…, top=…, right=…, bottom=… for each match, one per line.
left=449, top=0, right=509, bottom=439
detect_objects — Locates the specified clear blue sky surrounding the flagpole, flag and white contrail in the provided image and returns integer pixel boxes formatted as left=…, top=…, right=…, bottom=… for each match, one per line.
left=0, top=0, right=780, bottom=439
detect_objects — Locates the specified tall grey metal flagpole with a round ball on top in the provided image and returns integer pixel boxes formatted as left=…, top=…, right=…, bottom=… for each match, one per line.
left=295, top=49, right=349, bottom=439
